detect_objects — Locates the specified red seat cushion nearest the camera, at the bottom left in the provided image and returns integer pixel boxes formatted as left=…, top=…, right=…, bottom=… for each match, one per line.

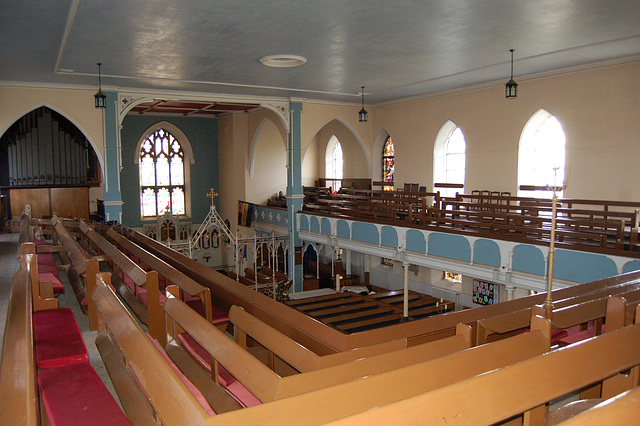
left=38, top=362, right=131, bottom=426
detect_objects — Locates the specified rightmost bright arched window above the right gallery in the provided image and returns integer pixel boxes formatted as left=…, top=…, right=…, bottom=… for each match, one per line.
left=518, top=109, right=565, bottom=198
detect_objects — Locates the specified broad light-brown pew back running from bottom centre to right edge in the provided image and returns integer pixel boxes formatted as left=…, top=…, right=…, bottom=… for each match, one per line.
left=328, top=310, right=640, bottom=424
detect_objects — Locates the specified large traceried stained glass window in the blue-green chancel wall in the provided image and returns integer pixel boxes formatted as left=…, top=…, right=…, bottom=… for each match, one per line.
left=139, top=129, right=186, bottom=217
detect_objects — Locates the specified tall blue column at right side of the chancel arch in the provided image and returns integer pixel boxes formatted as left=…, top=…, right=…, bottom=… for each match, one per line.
left=287, top=102, right=304, bottom=292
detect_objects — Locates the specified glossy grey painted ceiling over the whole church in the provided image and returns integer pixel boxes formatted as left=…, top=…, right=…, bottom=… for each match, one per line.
left=0, top=0, right=640, bottom=104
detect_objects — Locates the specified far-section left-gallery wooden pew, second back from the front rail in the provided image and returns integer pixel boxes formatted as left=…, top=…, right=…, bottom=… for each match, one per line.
left=80, top=222, right=167, bottom=346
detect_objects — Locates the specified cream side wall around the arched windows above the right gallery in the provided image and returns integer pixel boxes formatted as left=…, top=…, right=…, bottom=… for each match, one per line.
left=370, top=62, right=640, bottom=200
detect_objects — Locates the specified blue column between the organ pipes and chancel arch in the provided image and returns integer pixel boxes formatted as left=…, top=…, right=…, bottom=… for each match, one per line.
left=102, top=92, right=122, bottom=223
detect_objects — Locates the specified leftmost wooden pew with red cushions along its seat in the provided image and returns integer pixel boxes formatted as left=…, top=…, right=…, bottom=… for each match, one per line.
left=0, top=250, right=130, bottom=425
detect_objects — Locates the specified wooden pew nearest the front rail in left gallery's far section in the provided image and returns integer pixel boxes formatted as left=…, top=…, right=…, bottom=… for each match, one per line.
left=107, top=229, right=229, bottom=331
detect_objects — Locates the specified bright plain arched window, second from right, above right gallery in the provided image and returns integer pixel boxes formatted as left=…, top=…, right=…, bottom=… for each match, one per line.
left=433, top=121, right=467, bottom=197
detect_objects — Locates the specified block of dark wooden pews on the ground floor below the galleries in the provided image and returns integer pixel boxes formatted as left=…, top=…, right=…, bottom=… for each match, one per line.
left=286, top=291, right=455, bottom=334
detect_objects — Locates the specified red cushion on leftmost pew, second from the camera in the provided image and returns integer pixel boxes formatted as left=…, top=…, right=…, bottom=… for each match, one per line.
left=33, top=308, right=89, bottom=369
